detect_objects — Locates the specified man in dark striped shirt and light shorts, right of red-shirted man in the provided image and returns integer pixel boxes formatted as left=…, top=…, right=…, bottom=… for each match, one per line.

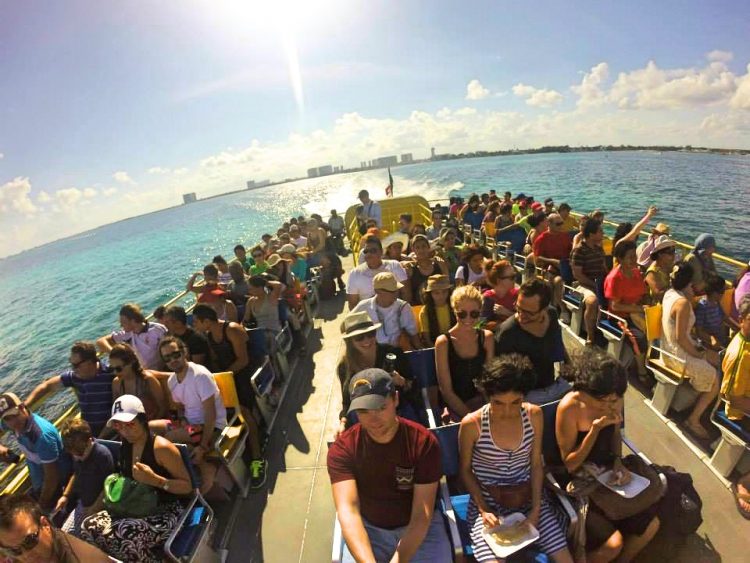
left=570, top=218, right=607, bottom=344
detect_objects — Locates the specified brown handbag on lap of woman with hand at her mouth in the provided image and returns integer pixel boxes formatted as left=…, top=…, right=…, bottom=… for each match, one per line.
left=589, top=455, right=664, bottom=521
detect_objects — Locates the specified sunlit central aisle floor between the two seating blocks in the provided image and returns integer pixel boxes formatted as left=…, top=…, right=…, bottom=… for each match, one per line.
left=227, top=288, right=346, bottom=563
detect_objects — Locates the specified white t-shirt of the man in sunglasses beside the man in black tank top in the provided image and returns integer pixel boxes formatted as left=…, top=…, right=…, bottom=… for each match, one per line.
left=167, top=362, right=227, bottom=430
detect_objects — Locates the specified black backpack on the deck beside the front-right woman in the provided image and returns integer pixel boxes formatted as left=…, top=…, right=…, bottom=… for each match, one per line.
left=654, top=465, right=703, bottom=536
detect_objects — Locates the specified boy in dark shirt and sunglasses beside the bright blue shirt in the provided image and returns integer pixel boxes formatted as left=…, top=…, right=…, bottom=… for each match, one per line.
left=55, top=418, right=115, bottom=535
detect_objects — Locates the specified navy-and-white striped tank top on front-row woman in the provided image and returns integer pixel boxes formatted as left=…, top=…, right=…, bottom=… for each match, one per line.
left=471, top=405, right=534, bottom=492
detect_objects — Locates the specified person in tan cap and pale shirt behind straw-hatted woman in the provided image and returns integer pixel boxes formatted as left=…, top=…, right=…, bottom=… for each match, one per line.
left=352, top=272, right=421, bottom=350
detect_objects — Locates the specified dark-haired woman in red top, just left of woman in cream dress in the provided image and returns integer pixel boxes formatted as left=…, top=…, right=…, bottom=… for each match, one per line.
left=604, top=240, right=648, bottom=378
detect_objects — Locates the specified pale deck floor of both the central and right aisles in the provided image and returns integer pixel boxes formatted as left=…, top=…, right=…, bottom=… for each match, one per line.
left=223, top=270, right=750, bottom=563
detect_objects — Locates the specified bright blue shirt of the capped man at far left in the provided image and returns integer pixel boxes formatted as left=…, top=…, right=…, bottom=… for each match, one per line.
left=10, top=413, right=71, bottom=491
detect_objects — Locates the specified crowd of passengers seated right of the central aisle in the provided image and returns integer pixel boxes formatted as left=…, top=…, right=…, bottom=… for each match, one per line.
left=328, top=191, right=750, bottom=561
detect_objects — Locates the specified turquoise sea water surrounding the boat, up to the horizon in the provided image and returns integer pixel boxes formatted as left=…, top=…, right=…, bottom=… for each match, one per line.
left=0, top=152, right=750, bottom=420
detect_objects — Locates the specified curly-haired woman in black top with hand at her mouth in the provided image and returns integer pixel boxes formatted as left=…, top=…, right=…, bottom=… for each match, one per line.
left=555, top=348, right=659, bottom=562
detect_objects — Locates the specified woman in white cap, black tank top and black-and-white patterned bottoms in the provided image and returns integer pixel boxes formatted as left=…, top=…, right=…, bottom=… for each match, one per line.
left=81, top=395, right=192, bottom=563
